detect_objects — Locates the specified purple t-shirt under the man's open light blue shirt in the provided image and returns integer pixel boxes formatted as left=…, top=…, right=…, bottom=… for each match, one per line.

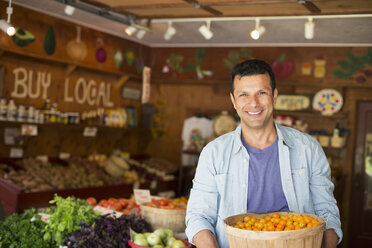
left=242, top=136, right=289, bottom=213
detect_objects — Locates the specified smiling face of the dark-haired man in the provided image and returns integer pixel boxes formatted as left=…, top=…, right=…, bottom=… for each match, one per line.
left=230, top=74, right=278, bottom=129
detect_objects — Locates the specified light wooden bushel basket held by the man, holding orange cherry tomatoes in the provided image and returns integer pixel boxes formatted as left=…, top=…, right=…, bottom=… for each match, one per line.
left=224, top=212, right=325, bottom=248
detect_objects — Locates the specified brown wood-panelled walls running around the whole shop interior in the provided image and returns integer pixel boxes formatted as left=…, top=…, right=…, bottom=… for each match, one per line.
left=0, top=2, right=372, bottom=245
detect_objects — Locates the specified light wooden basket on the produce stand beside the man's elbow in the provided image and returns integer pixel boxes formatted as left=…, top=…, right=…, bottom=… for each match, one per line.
left=141, top=205, right=186, bottom=233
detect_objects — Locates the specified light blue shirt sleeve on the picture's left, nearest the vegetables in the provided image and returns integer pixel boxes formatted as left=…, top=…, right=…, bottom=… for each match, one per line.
left=185, top=145, right=218, bottom=243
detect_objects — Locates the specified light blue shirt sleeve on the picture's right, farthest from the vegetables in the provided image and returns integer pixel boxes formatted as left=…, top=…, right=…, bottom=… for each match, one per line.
left=310, top=142, right=343, bottom=243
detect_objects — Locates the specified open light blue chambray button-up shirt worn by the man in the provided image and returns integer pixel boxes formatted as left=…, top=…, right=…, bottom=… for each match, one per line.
left=186, top=122, right=342, bottom=248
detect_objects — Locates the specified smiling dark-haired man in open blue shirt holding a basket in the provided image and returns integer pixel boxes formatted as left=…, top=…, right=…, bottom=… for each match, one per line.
left=186, top=60, right=342, bottom=248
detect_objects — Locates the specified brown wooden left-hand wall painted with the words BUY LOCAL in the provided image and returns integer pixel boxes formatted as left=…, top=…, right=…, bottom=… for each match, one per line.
left=0, top=2, right=151, bottom=157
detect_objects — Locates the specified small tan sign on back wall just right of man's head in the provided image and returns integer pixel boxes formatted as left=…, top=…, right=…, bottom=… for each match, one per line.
left=274, top=94, right=311, bottom=111
